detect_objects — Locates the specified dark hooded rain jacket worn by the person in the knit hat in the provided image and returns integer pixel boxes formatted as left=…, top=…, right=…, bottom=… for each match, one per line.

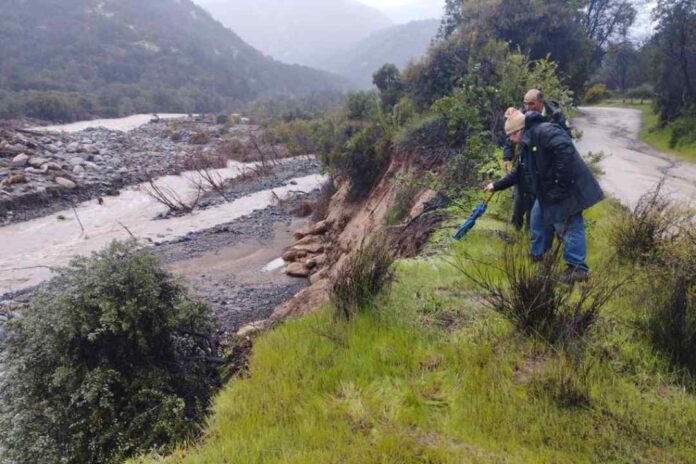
left=493, top=112, right=604, bottom=225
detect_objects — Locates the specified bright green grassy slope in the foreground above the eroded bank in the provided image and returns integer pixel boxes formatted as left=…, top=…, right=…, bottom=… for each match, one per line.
left=135, top=196, right=696, bottom=464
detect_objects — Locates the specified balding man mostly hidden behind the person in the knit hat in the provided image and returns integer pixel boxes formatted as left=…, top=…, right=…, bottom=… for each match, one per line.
left=503, top=89, right=571, bottom=229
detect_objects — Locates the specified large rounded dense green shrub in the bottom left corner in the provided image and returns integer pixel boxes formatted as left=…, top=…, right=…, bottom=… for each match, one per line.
left=0, top=242, right=218, bottom=464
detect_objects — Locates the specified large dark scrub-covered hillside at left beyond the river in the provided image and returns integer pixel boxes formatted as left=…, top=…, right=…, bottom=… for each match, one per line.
left=0, top=0, right=343, bottom=120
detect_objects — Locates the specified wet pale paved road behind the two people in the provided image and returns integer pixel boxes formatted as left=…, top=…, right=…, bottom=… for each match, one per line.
left=573, top=107, right=696, bottom=207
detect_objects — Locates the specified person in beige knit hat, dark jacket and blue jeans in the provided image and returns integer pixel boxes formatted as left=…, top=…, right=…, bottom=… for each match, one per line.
left=486, top=111, right=604, bottom=283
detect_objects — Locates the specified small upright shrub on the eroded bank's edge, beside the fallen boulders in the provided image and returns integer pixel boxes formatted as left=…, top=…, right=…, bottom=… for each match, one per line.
left=330, top=236, right=394, bottom=319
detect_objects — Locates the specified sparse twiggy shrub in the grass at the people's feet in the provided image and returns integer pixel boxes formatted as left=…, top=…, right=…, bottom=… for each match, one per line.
left=459, top=243, right=619, bottom=344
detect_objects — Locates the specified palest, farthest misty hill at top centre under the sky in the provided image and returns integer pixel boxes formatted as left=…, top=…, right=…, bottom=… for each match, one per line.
left=196, top=0, right=392, bottom=67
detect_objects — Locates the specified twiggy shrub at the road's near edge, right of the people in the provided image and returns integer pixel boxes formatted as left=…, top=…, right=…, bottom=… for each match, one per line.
left=609, top=183, right=689, bottom=263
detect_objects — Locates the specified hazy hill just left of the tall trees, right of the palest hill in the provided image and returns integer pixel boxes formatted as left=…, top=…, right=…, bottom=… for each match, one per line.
left=325, top=19, right=440, bottom=88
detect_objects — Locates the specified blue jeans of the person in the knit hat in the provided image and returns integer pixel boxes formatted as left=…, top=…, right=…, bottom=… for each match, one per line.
left=530, top=200, right=590, bottom=271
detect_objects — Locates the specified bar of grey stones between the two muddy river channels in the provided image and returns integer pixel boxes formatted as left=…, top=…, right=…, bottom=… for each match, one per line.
left=0, top=116, right=268, bottom=224
